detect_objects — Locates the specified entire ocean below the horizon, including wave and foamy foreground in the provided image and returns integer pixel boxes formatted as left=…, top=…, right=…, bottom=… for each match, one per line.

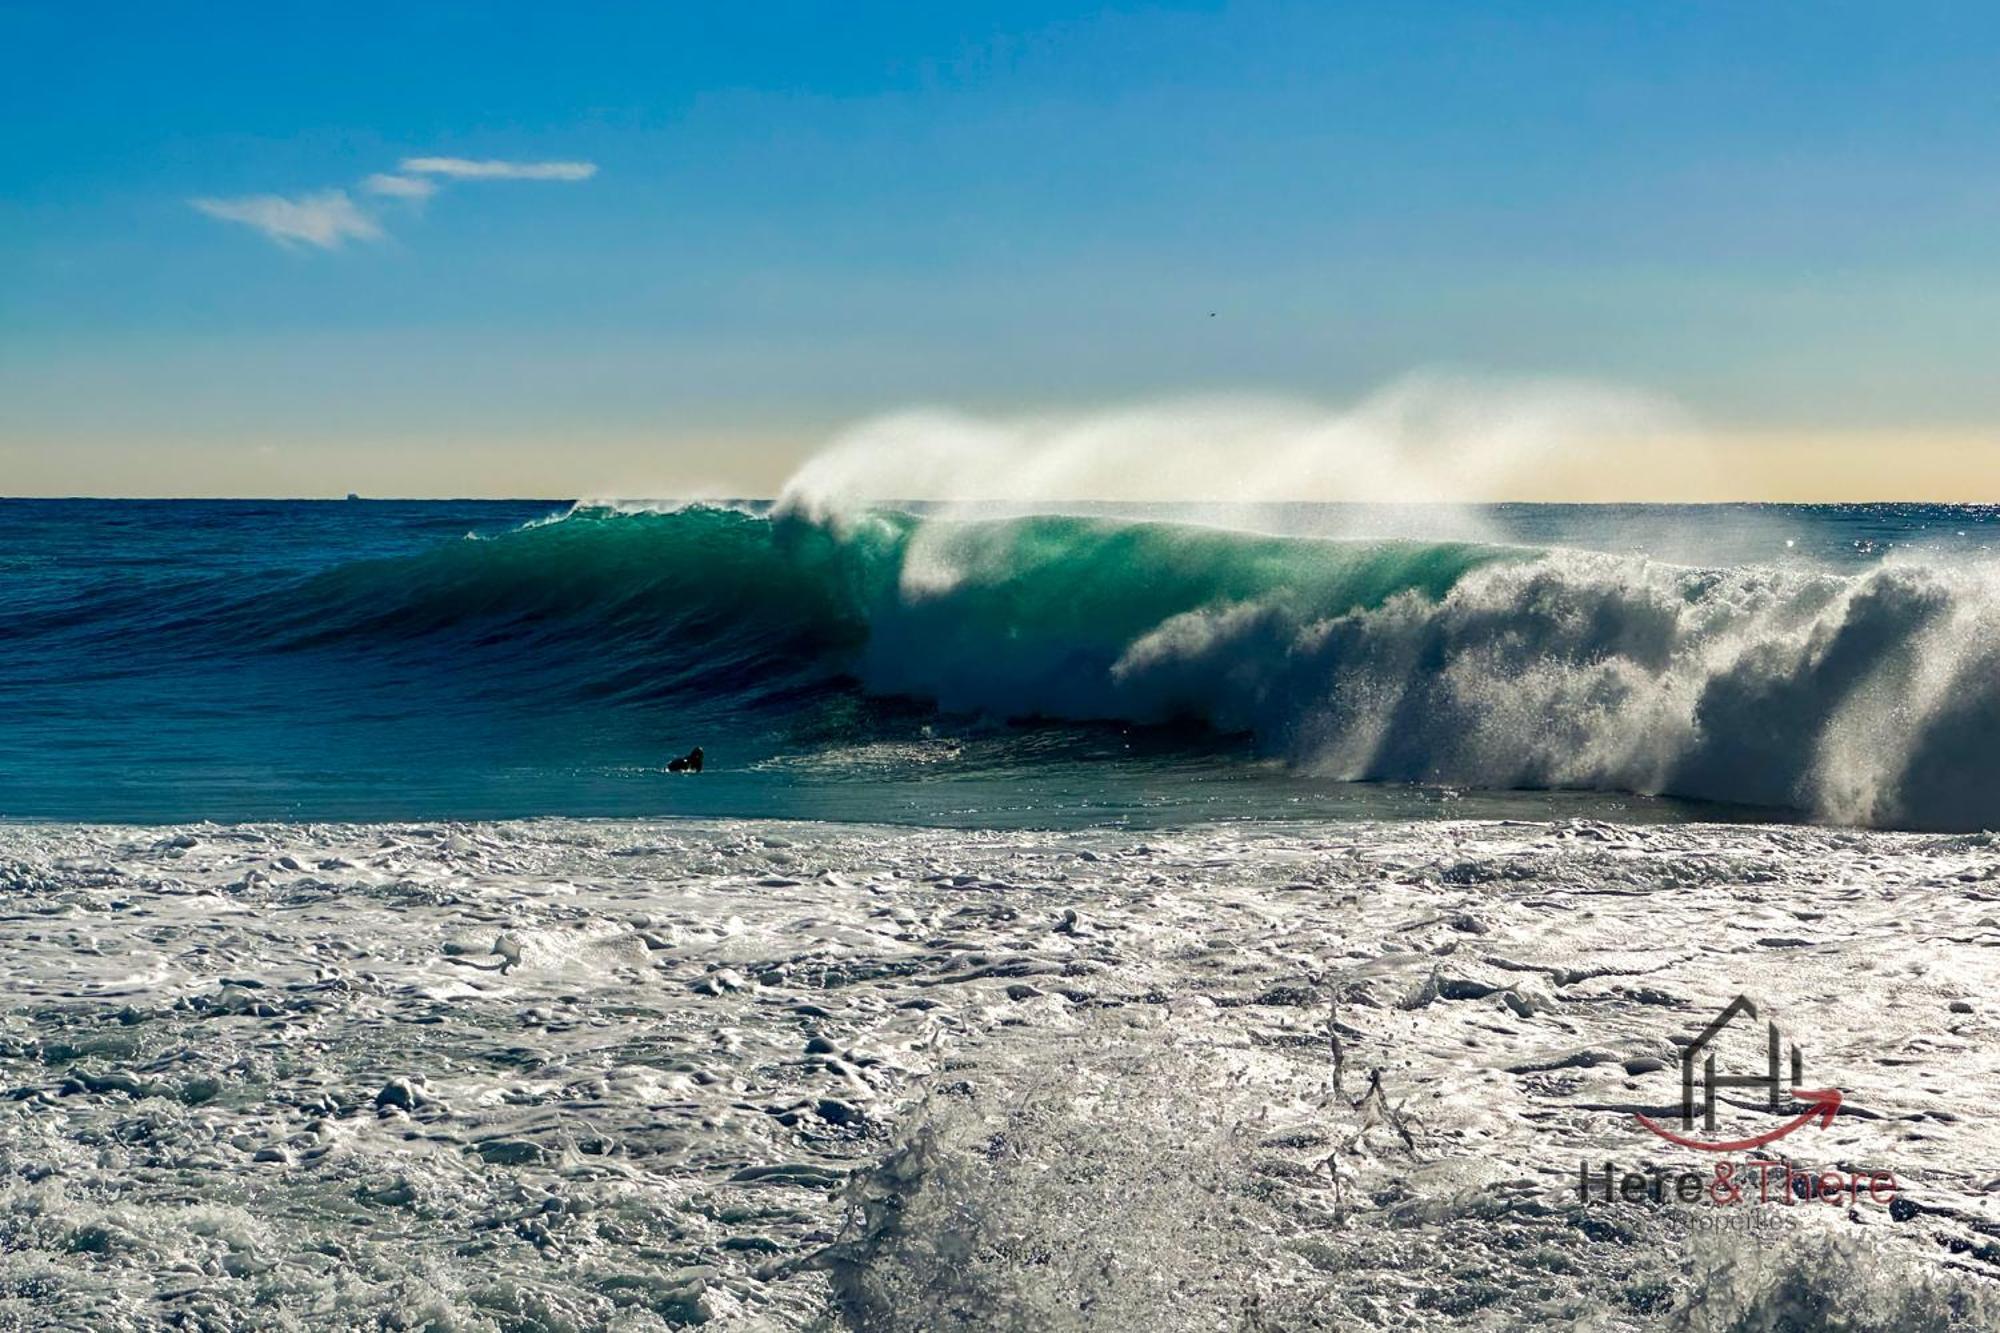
left=0, top=500, right=2000, bottom=1333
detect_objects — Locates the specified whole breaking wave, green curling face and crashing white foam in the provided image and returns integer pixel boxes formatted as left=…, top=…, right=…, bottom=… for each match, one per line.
left=94, top=506, right=2000, bottom=829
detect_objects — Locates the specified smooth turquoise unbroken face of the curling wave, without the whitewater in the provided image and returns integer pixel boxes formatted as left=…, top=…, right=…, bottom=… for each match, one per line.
left=148, top=506, right=1504, bottom=721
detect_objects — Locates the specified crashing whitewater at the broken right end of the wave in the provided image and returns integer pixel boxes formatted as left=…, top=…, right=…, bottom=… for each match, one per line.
left=1112, top=552, right=2000, bottom=827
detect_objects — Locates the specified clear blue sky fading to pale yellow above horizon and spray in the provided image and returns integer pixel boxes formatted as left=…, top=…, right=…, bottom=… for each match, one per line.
left=0, top=0, right=2000, bottom=492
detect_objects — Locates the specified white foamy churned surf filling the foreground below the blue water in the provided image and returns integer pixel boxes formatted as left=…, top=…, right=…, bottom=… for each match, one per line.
left=0, top=821, right=2000, bottom=1329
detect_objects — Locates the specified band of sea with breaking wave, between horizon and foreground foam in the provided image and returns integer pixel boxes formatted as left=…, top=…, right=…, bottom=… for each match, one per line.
left=0, top=500, right=2000, bottom=827
